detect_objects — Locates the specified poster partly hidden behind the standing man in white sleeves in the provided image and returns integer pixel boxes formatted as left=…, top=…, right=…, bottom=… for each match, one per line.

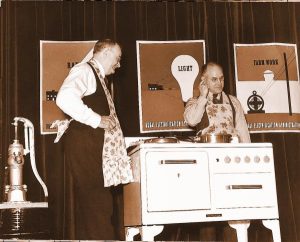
left=40, top=40, right=96, bottom=134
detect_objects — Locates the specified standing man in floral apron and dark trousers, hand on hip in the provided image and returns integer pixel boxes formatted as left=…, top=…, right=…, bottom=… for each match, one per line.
left=56, top=39, right=132, bottom=240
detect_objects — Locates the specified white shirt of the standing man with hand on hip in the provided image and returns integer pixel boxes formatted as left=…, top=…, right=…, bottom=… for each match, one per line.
left=56, top=60, right=105, bottom=128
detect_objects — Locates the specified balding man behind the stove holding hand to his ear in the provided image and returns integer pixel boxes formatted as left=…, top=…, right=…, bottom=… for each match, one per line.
left=184, top=62, right=251, bottom=143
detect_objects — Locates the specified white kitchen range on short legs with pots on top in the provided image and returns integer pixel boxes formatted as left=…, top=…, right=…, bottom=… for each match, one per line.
left=124, top=141, right=281, bottom=242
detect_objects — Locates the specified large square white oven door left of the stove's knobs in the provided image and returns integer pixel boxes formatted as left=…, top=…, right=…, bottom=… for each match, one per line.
left=145, top=151, right=211, bottom=212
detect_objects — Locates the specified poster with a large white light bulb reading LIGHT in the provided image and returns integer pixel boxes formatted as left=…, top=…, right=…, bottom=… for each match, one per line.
left=136, top=40, right=205, bottom=133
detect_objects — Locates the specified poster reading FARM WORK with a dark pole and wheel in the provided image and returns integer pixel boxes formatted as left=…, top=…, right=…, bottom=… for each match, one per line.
left=234, top=43, right=300, bottom=133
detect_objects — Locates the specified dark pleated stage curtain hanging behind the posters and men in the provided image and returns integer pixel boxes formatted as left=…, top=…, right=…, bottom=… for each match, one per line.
left=0, top=0, right=300, bottom=242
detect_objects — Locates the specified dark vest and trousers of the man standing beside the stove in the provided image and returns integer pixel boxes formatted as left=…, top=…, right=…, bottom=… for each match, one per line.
left=64, top=62, right=115, bottom=240
